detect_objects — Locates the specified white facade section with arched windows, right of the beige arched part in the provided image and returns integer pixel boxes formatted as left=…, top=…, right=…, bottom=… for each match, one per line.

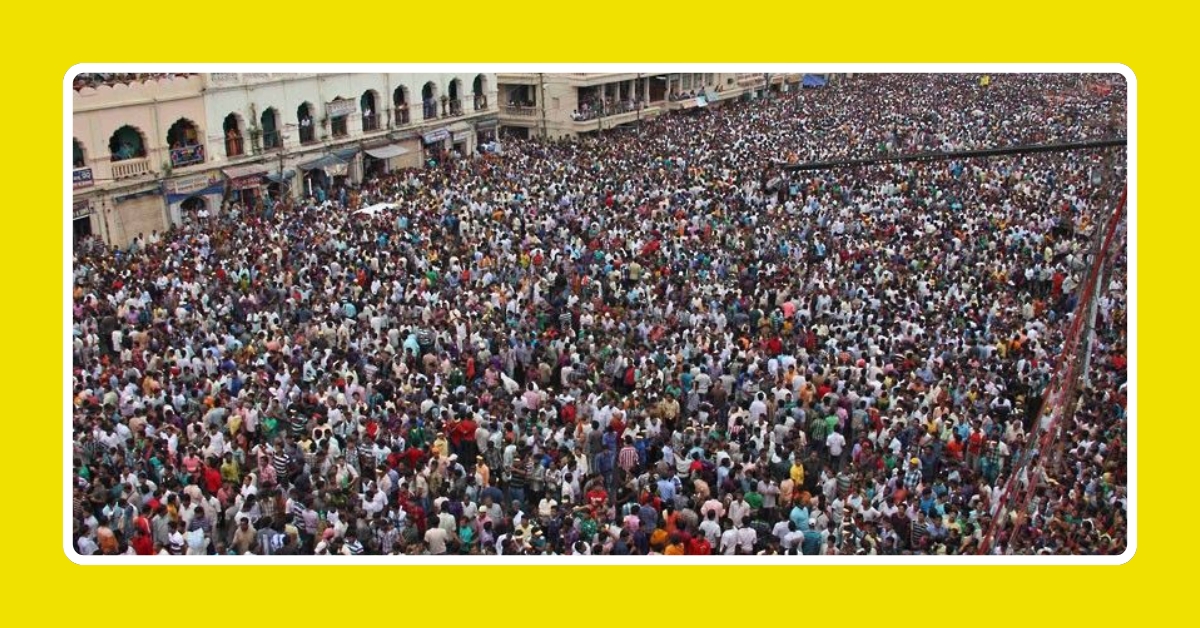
left=204, top=73, right=498, bottom=208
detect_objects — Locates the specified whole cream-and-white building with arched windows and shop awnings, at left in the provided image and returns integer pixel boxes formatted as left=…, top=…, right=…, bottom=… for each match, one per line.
left=72, top=73, right=498, bottom=245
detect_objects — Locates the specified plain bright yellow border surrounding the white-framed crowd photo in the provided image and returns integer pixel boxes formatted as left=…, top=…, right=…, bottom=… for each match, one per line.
left=0, top=0, right=1198, bottom=627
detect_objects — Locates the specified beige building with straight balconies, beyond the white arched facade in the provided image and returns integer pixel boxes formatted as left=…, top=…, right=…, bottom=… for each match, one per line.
left=497, top=72, right=800, bottom=139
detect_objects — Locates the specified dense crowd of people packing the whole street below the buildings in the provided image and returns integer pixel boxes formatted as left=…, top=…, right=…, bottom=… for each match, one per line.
left=68, top=74, right=1128, bottom=560
